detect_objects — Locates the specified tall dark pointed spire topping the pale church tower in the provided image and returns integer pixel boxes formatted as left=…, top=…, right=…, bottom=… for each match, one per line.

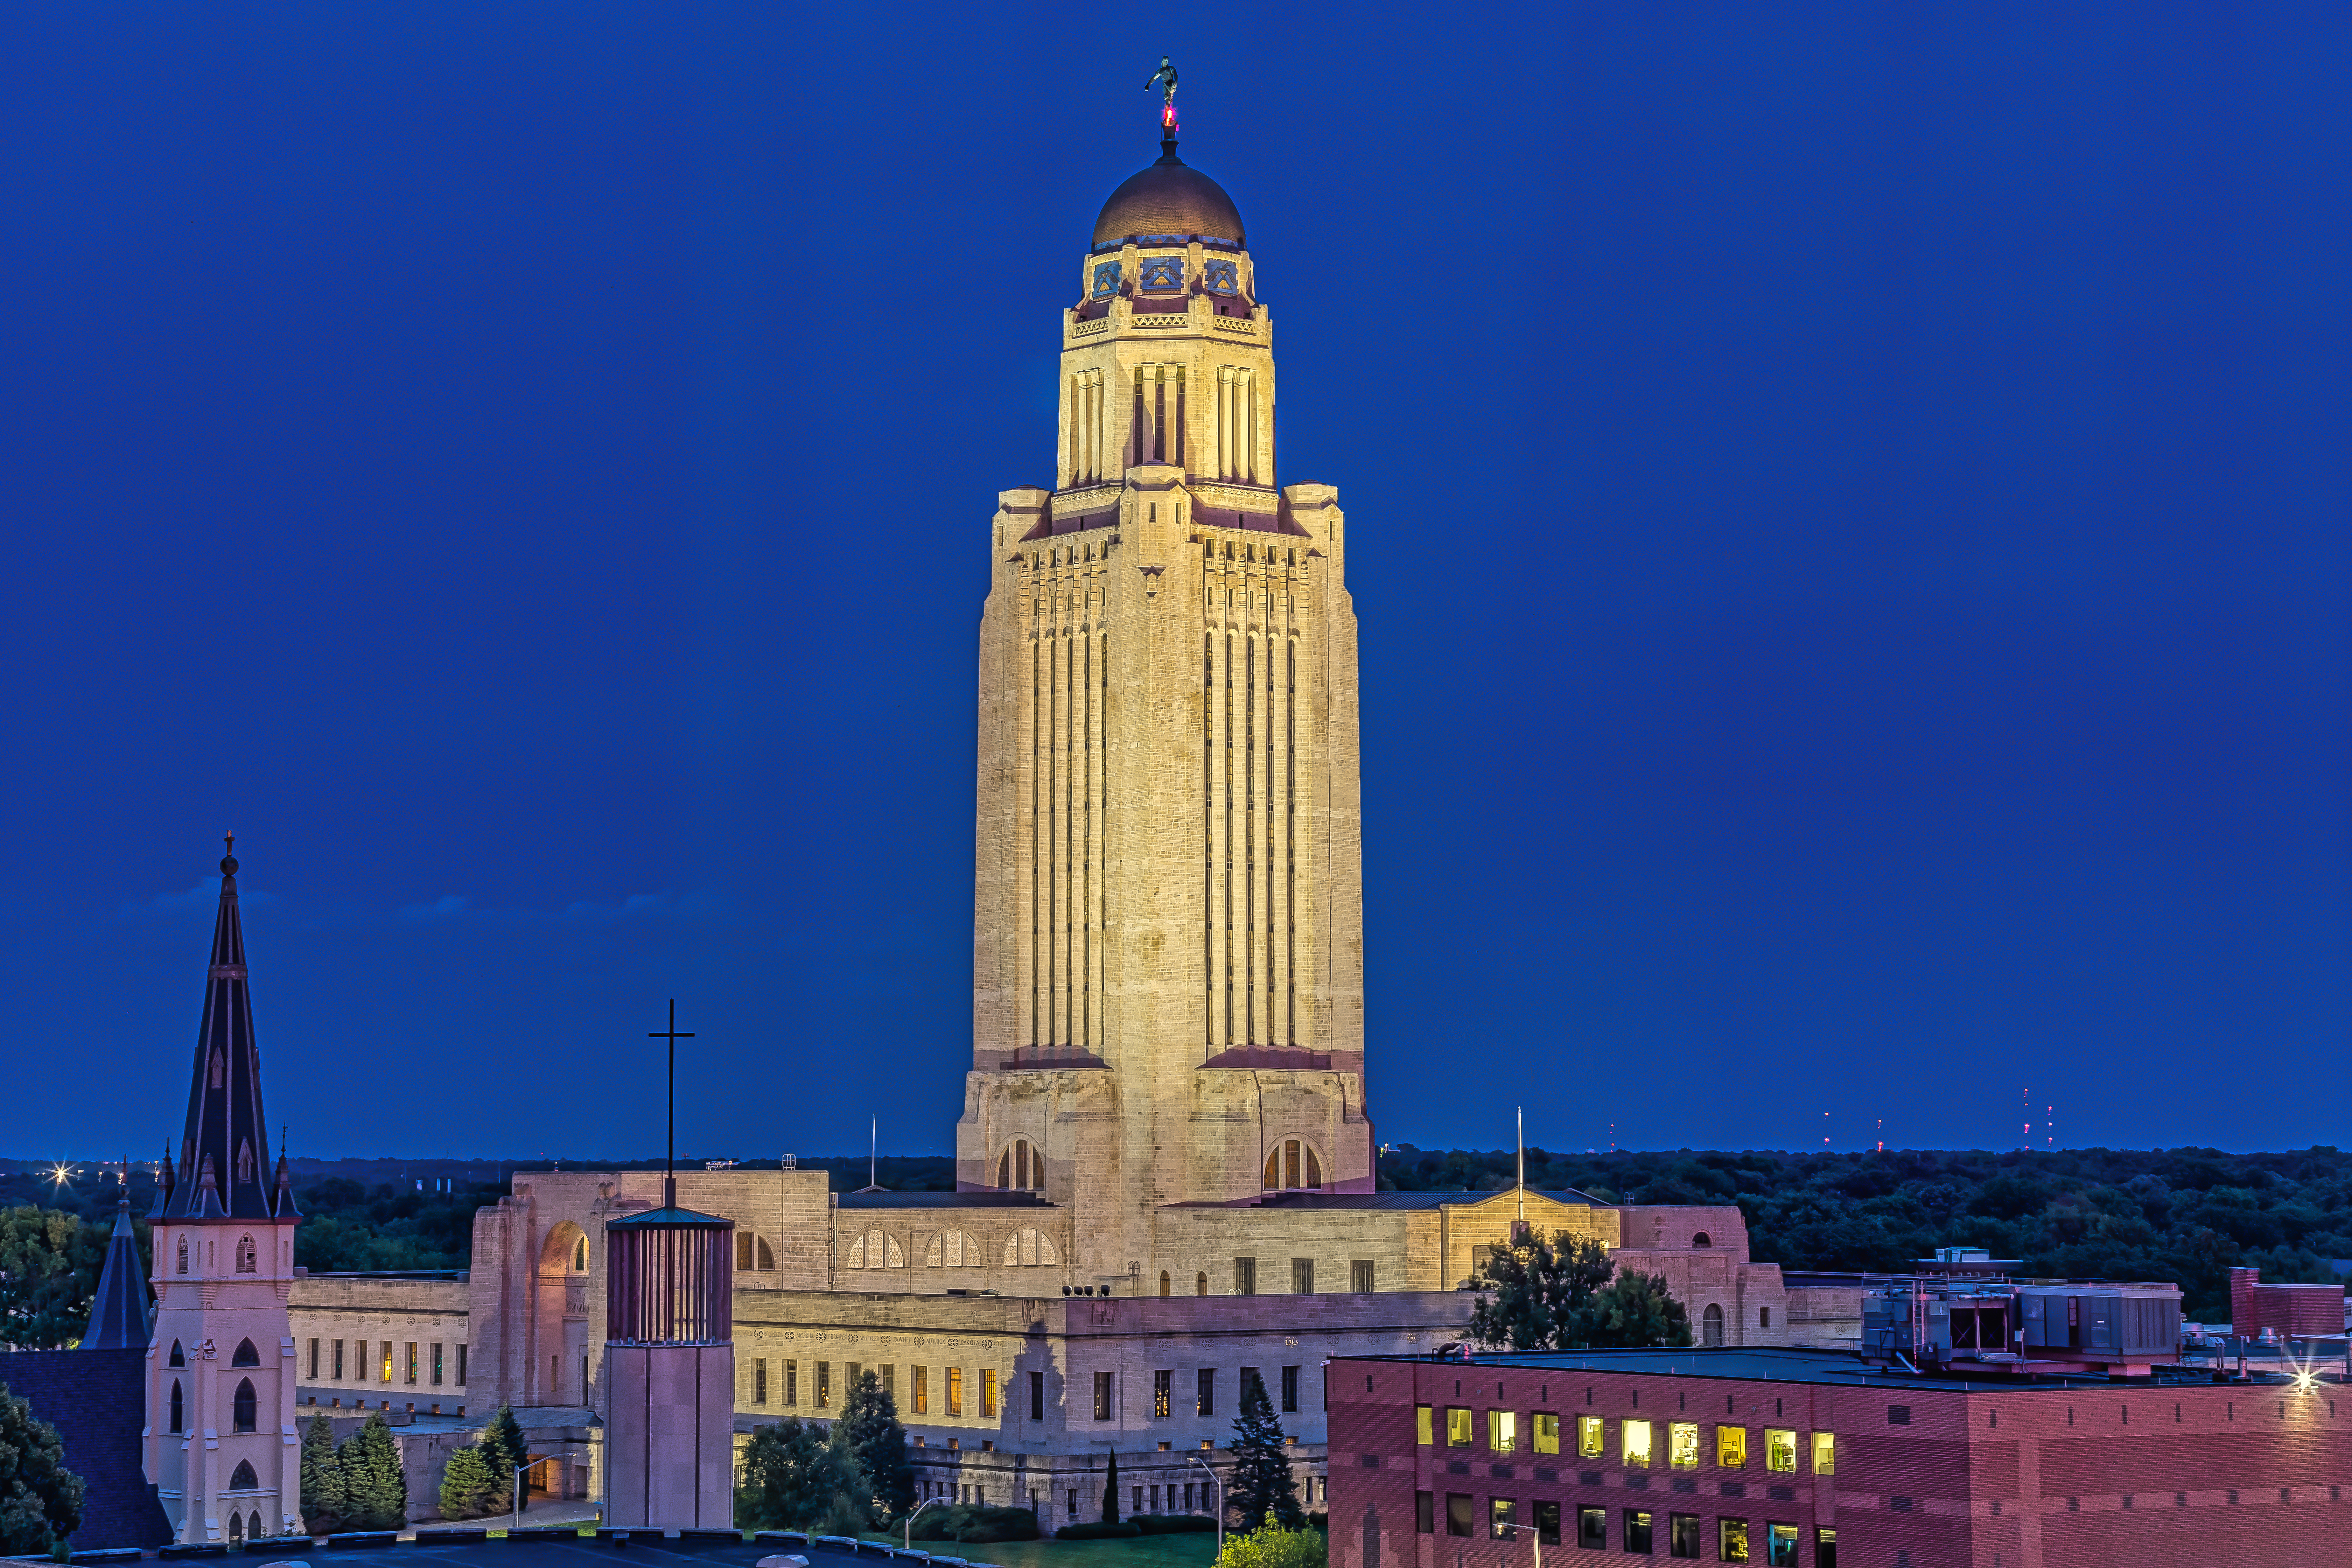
left=162, top=834, right=271, bottom=1220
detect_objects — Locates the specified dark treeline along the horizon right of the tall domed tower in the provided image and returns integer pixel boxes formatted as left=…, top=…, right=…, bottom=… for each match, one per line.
left=1381, top=1145, right=2352, bottom=1319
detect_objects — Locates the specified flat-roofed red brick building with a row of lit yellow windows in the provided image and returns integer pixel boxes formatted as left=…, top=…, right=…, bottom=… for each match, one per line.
left=1329, top=1349, right=2352, bottom=1568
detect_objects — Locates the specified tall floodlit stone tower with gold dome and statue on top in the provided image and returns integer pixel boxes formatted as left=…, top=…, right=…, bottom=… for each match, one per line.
left=957, top=98, right=1373, bottom=1293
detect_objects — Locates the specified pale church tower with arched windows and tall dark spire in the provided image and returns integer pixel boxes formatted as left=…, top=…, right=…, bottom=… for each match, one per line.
left=146, top=834, right=303, bottom=1542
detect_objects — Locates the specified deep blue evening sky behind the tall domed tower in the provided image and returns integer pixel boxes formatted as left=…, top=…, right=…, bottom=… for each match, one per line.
left=0, top=0, right=2352, bottom=1157
